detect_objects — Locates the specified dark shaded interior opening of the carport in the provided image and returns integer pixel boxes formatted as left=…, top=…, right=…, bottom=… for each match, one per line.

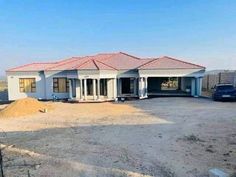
left=148, top=77, right=191, bottom=96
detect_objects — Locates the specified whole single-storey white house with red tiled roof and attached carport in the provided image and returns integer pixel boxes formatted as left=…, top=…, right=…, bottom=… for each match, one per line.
left=6, top=52, right=205, bottom=101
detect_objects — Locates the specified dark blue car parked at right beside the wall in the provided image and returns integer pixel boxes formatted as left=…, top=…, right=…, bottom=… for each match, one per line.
left=212, top=84, right=236, bottom=101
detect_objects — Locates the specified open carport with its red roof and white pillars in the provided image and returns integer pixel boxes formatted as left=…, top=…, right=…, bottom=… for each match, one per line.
left=138, top=57, right=205, bottom=98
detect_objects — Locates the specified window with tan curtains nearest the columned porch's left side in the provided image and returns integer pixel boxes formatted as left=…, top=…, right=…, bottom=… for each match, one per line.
left=53, top=78, right=69, bottom=93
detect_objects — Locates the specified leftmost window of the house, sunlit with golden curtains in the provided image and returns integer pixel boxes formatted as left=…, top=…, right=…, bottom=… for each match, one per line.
left=19, top=78, right=36, bottom=93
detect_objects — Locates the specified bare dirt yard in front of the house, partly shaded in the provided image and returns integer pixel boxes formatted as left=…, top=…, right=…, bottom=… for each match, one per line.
left=0, top=98, right=236, bottom=177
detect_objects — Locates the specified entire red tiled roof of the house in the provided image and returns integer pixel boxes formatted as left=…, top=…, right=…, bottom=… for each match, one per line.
left=8, top=52, right=204, bottom=71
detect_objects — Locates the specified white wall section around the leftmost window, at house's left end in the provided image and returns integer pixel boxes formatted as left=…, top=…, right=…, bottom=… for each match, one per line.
left=7, top=72, right=45, bottom=100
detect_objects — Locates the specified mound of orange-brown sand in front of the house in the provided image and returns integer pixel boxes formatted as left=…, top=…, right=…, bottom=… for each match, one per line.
left=0, top=98, right=51, bottom=117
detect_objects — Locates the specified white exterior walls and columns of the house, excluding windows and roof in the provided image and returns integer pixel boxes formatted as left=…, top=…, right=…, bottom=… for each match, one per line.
left=7, top=69, right=205, bottom=100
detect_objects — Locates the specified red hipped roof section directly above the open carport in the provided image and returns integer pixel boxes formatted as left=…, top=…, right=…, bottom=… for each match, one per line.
left=138, top=56, right=205, bottom=69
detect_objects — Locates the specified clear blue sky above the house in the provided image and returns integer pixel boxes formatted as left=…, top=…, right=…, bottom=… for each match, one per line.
left=0, top=0, right=236, bottom=74
